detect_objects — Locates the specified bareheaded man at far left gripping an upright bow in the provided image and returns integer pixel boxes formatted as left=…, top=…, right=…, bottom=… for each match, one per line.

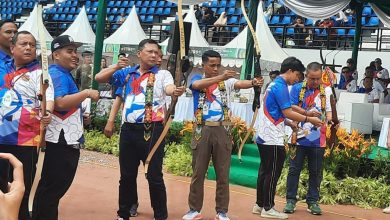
left=0, top=31, right=54, bottom=220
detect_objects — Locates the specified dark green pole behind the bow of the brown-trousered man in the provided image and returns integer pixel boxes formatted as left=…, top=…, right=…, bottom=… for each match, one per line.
left=240, top=0, right=259, bottom=79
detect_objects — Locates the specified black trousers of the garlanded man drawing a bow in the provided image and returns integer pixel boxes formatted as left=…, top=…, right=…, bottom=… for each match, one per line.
left=117, top=123, right=168, bottom=220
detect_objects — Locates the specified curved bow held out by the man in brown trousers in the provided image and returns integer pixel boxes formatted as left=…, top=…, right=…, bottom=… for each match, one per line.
left=238, top=0, right=262, bottom=162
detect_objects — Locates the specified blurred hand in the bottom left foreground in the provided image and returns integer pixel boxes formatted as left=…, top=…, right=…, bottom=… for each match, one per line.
left=0, top=153, right=25, bottom=219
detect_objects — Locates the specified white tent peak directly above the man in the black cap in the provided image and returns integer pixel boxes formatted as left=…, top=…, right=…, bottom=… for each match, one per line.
left=61, top=6, right=96, bottom=44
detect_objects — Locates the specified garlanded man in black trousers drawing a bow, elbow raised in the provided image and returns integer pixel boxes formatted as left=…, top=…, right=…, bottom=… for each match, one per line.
left=96, top=39, right=185, bottom=220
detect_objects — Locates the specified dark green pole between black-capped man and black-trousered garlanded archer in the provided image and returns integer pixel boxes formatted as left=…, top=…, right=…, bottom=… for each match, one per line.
left=92, top=0, right=107, bottom=90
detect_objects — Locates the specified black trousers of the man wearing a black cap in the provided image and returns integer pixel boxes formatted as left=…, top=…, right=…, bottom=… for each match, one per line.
left=33, top=142, right=80, bottom=220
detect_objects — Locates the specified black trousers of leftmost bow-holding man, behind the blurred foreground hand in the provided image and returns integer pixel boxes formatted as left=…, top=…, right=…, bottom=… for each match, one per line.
left=0, top=144, right=37, bottom=220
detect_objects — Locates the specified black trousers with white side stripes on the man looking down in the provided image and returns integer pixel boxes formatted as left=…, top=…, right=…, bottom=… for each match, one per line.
left=256, top=144, right=286, bottom=211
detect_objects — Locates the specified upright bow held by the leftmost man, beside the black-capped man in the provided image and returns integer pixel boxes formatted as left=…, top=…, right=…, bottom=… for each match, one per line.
left=28, top=3, right=49, bottom=216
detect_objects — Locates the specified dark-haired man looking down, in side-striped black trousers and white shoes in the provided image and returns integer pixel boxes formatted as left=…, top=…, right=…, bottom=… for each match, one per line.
left=252, top=57, right=322, bottom=219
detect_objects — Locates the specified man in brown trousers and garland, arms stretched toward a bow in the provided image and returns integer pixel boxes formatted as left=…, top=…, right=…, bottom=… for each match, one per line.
left=183, top=50, right=264, bottom=220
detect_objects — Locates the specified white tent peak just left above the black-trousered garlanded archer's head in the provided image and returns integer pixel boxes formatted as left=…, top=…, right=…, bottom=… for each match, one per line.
left=104, top=6, right=147, bottom=45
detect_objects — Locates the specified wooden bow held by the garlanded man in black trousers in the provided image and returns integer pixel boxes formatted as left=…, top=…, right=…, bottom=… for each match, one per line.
left=144, top=0, right=189, bottom=178
